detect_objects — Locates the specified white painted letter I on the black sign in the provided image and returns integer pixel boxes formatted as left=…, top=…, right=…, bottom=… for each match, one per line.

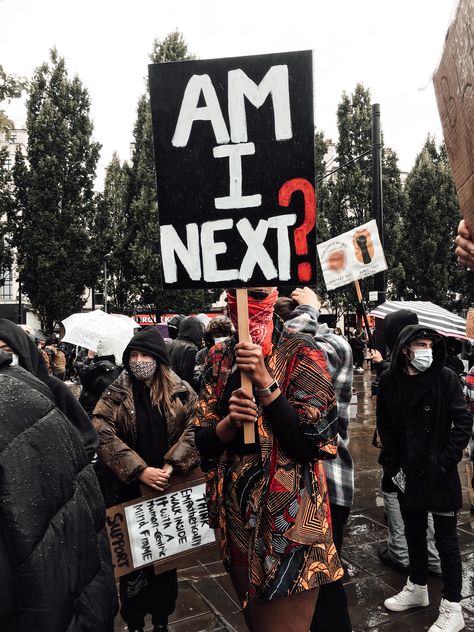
left=212, top=143, right=262, bottom=209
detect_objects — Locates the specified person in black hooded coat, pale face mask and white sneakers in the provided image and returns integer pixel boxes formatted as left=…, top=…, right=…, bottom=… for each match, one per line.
left=377, top=325, right=472, bottom=632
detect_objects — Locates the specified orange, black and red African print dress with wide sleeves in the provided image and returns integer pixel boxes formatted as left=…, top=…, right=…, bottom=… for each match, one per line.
left=195, top=331, right=343, bottom=600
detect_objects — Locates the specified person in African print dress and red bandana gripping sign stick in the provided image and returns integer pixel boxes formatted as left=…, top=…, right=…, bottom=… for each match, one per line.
left=195, top=288, right=343, bottom=632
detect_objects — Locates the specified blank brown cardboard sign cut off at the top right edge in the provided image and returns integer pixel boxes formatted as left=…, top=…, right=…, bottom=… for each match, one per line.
left=433, top=0, right=474, bottom=234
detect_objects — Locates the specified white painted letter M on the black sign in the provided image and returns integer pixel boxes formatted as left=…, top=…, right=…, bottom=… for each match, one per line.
left=229, top=65, right=293, bottom=143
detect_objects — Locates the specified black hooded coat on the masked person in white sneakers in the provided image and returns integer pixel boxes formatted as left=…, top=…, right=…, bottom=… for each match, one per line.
left=377, top=325, right=472, bottom=511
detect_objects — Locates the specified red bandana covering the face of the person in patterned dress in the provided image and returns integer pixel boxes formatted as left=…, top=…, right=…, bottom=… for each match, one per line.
left=227, top=290, right=278, bottom=356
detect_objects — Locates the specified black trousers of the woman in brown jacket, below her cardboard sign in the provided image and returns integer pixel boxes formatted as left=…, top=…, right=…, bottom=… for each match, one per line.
left=119, top=566, right=178, bottom=628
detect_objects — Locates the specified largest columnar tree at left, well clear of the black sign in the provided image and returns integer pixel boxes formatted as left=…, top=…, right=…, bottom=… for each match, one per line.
left=14, top=49, right=100, bottom=331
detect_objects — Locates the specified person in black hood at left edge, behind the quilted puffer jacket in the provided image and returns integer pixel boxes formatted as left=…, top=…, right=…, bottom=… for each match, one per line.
left=0, top=318, right=99, bottom=460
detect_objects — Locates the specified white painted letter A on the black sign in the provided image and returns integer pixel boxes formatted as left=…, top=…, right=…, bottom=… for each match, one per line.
left=171, top=75, right=230, bottom=147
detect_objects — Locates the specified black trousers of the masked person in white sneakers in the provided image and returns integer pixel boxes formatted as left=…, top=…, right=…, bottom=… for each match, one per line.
left=399, top=502, right=462, bottom=602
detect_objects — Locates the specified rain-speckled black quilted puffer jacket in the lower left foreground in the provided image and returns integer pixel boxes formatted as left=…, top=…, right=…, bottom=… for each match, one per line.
left=0, top=352, right=117, bottom=632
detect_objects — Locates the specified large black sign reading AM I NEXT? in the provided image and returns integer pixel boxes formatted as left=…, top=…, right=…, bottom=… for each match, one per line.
left=149, top=51, right=316, bottom=288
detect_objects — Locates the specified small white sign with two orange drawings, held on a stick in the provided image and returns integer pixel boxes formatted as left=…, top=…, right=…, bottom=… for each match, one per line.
left=318, top=219, right=387, bottom=290
